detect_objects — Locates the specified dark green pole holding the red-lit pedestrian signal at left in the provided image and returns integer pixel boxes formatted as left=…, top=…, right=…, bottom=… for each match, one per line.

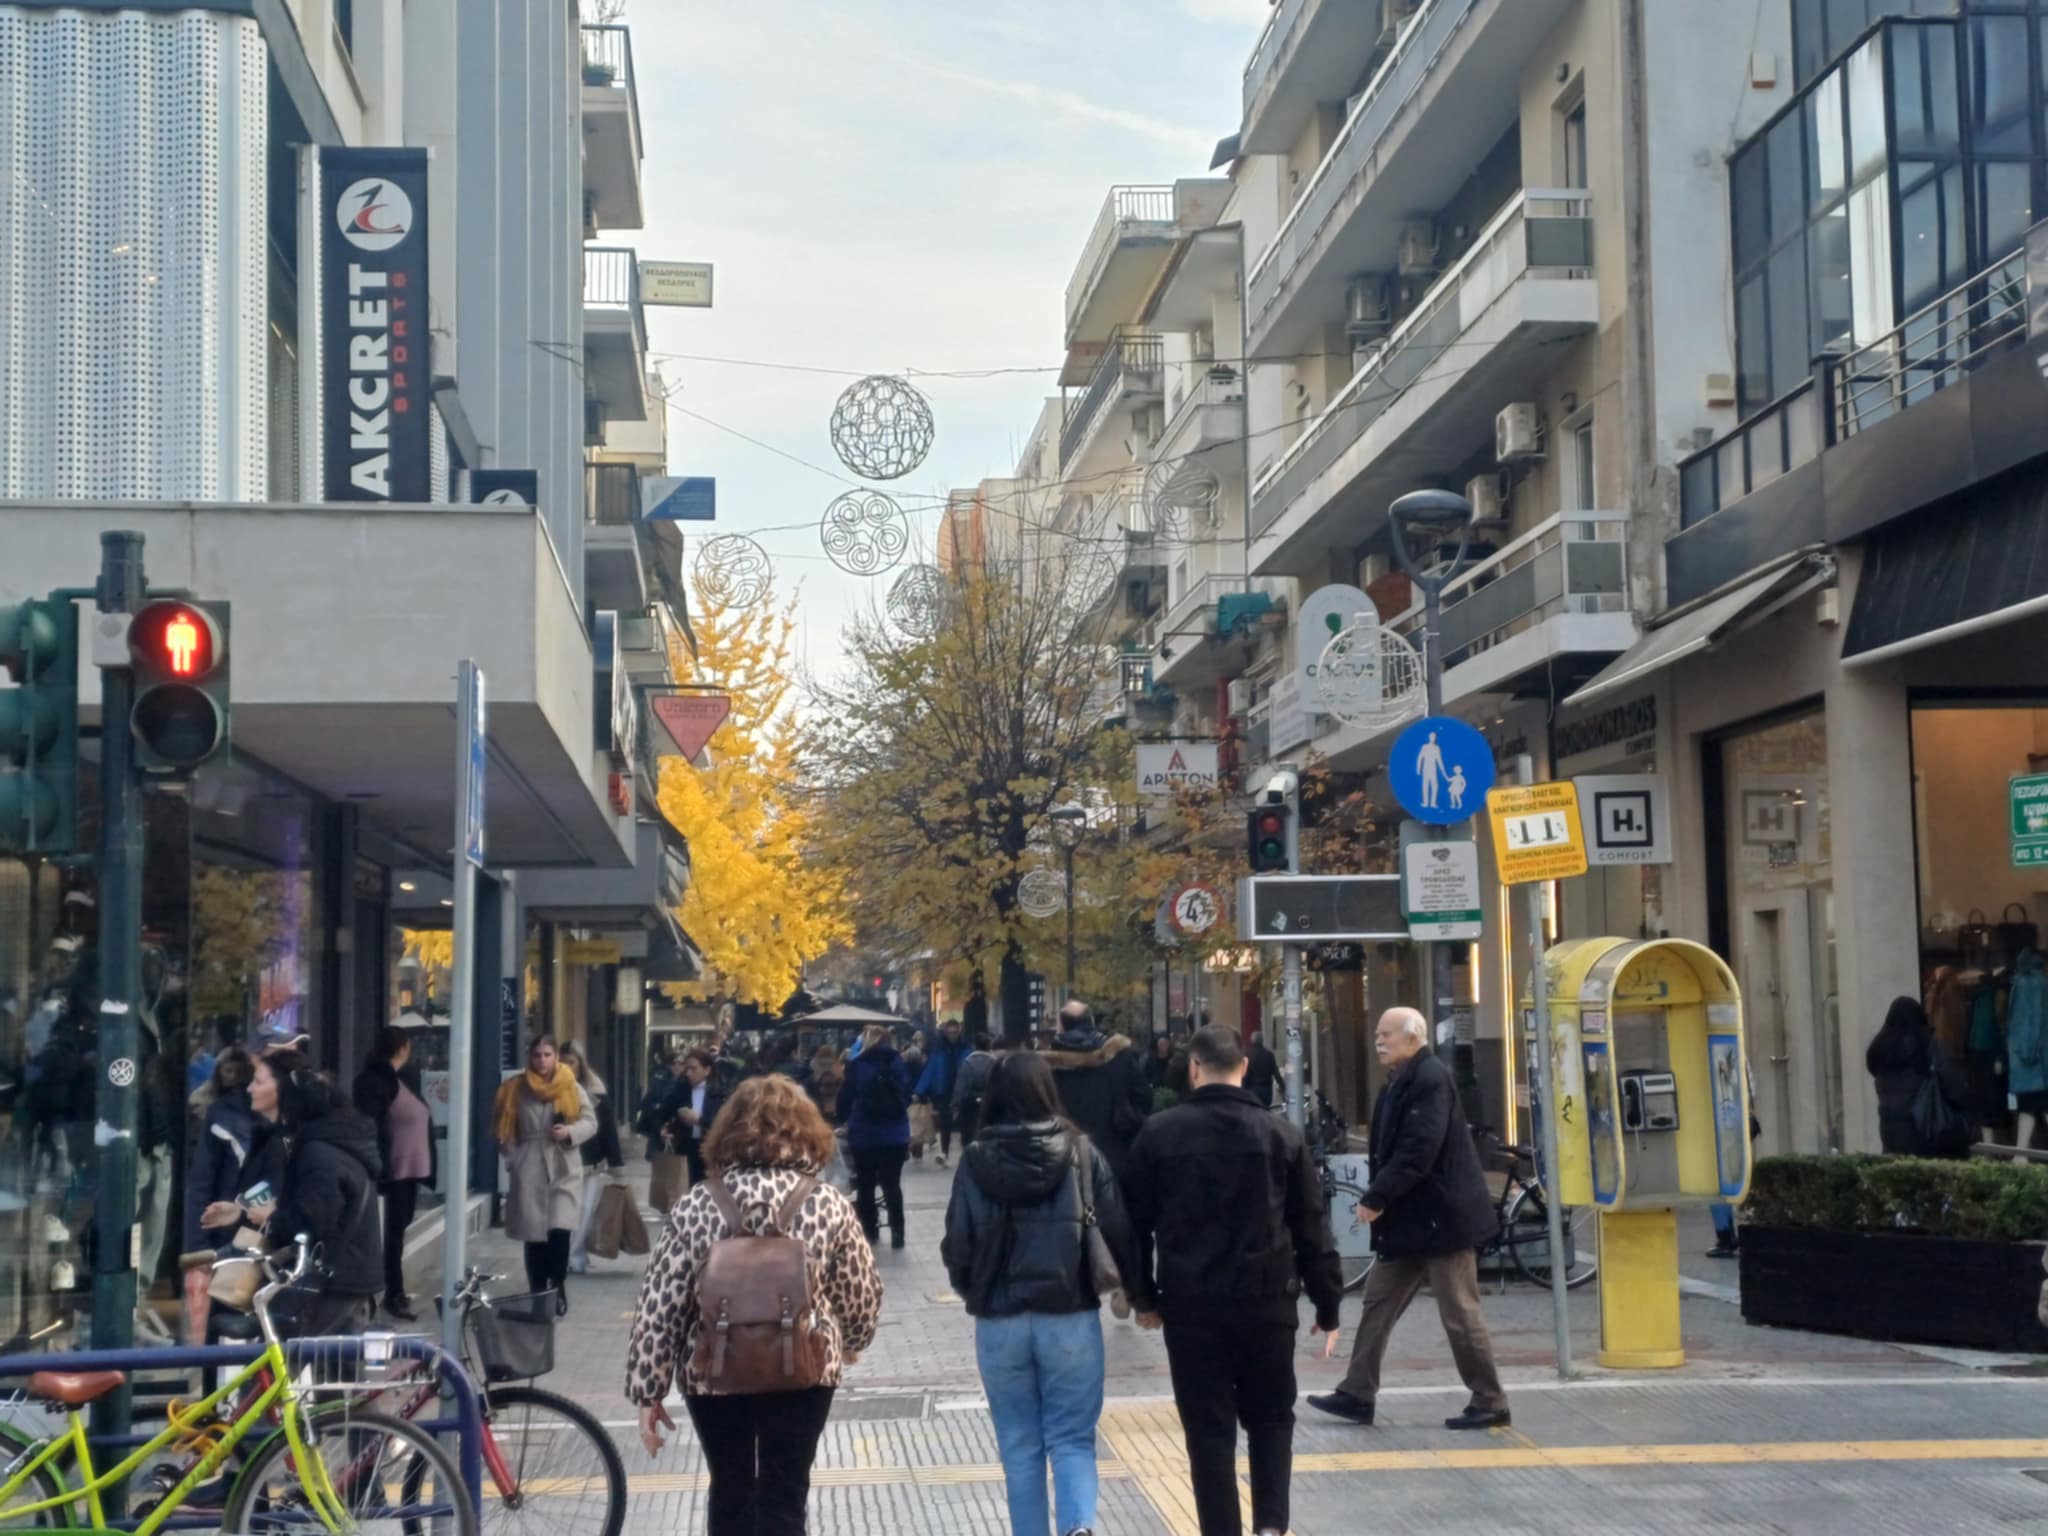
left=92, top=530, right=147, bottom=1458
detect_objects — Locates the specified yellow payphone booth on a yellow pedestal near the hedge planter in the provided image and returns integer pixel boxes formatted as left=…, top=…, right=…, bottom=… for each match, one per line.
left=1524, top=938, right=1749, bottom=1368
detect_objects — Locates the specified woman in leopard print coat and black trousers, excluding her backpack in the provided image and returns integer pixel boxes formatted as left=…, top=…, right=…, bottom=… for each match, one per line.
left=627, top=1077, right=883, bottom=1536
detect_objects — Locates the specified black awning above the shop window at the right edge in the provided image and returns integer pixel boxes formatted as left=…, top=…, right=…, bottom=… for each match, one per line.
left=1841, top=465, right=2048, bottom=666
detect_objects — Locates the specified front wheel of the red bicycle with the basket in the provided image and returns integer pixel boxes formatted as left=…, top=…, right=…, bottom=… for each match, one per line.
left=483, top=1386, right=627, bottom=1536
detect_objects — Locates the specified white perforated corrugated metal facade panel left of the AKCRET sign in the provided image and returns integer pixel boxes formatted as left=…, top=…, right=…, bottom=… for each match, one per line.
left=0, top=6, right=268, bottom=502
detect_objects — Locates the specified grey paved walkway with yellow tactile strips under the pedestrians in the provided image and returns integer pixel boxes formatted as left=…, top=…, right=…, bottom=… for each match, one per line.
left=403, top=1165, right=2048, bottom=1536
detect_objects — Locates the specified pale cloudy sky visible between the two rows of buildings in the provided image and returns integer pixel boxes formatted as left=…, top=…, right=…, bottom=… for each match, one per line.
left=602, top=0, right=1270, bottom=676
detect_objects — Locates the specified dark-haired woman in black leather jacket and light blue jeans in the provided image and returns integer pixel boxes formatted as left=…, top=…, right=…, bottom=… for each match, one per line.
left=944, top=1051, right=1137, bottom=1536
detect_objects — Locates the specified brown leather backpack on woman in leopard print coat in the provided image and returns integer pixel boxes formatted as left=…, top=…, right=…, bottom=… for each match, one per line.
left=692, top=1178, right=825, bottom=1397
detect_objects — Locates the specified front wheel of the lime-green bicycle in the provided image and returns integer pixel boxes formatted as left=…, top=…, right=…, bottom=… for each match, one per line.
left=221, top=1403, right=477, bottom=1536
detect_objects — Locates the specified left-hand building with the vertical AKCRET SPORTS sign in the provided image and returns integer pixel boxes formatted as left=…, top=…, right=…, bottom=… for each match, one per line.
left=0, top=0, right=690, bottom=1327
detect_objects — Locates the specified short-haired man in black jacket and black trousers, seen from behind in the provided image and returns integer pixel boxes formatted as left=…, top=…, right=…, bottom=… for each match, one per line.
left=1124, top=1026, right=1343, bottom=1536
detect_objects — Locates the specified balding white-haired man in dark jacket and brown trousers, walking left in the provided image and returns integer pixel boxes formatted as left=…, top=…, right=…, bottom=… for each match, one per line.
left=1309, top=1008, right=1507, bottom=1430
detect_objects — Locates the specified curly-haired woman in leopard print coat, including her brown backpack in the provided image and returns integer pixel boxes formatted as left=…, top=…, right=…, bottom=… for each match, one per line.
left=627, top=1077, right=883, bottom=1536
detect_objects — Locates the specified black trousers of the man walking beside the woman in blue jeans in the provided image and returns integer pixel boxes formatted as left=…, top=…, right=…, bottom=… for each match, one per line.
left=1165, top=1300, right=1296, bottom=1536
